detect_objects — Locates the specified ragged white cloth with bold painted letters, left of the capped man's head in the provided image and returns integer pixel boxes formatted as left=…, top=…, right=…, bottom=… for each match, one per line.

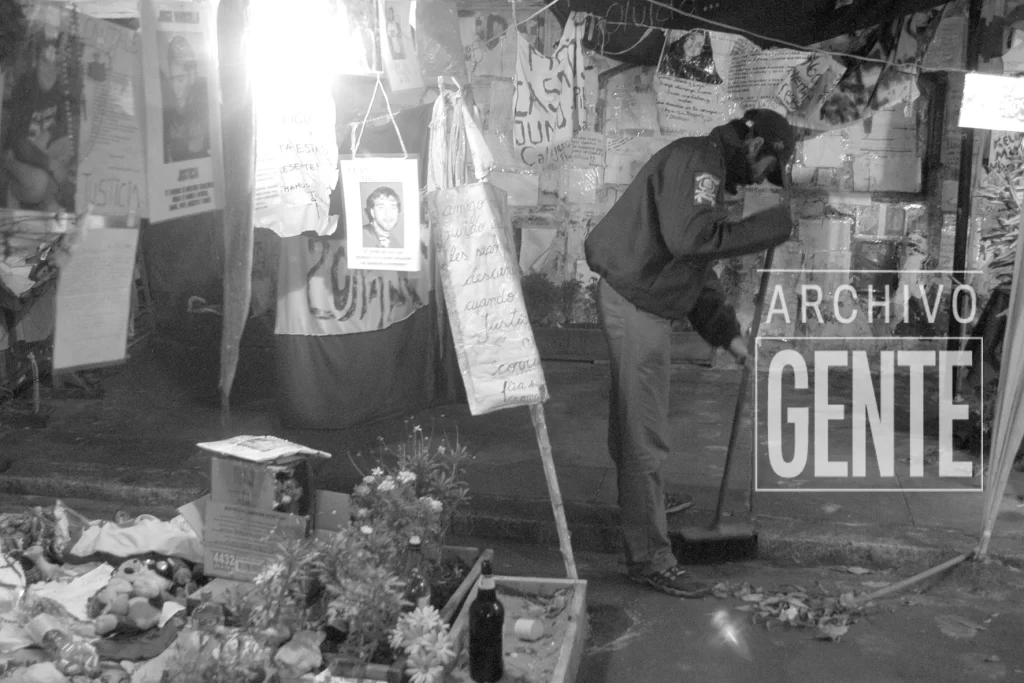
left=512, top=17, right=586, bottom=167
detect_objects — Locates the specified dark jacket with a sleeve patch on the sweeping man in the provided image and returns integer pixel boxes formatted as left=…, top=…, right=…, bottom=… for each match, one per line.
left=585, top=126, right=793, bottom=346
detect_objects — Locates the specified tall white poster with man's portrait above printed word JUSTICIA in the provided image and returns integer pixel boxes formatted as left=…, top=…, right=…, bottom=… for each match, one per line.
left=140, top=0, right=224, bottom=223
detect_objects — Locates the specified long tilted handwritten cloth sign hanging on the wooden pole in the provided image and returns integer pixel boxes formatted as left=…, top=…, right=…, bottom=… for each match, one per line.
left=428, top=182, right=548, bottom=415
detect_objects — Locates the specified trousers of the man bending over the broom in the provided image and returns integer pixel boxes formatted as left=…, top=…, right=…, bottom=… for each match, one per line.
left=597, top=280, right=676, bottom=573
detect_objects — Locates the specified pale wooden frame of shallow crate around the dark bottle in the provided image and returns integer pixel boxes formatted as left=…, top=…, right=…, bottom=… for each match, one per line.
left=452, top=577, right=590, bottom=683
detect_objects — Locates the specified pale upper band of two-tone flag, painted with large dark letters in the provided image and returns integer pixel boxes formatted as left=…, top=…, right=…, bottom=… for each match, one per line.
left=274, top=216, right=432, bottom=336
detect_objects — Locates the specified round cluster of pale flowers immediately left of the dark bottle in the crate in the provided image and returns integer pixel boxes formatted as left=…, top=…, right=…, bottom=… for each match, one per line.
left=391, top=606, right=455, bottom=683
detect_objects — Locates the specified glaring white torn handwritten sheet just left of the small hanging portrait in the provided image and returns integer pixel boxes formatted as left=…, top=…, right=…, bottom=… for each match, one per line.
left=254, top=90, right=338, bottom=238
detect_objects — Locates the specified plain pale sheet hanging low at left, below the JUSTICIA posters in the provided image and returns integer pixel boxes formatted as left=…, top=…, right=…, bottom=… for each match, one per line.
left=53, top=216, right=138, bottom=371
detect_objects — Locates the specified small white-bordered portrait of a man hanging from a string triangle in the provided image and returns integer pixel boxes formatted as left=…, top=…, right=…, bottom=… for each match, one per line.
left=340, top=156, right=420, bottom=271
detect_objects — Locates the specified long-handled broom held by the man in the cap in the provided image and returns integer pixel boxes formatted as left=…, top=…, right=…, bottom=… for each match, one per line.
left=673, top=248, right=775, bottom=564
